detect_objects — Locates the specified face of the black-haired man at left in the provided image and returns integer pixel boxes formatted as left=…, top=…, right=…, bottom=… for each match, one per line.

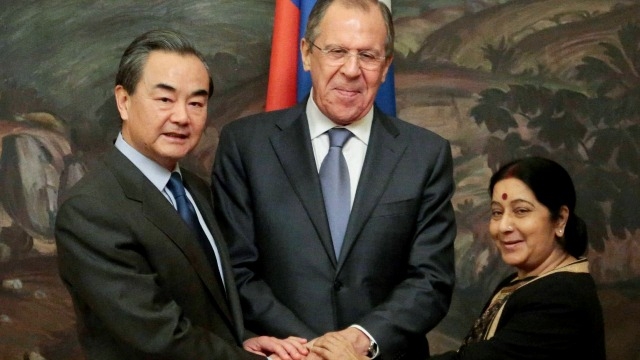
left=115, top=51, right=209, bottom=171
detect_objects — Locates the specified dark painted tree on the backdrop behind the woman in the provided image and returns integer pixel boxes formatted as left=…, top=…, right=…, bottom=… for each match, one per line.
left=471, top=24, right=640, bottom=251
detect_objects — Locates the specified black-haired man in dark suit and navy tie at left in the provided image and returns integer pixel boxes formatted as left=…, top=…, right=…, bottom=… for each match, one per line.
left=55, top=30, right=306, bottom=360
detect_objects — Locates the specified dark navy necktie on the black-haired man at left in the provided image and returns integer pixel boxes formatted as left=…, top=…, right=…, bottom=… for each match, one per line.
left=167, top=172, right=224, bottom=285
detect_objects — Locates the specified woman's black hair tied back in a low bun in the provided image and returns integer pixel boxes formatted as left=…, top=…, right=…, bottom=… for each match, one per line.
left=489, top=157, right=588, bottom=257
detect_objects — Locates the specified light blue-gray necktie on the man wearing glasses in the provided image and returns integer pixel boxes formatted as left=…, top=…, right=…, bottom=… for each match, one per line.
left=320, top=128, right=353, bottom=258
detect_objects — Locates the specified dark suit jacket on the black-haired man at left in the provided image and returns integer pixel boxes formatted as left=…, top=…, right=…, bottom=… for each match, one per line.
left=55, top=148, right=264, bottom=360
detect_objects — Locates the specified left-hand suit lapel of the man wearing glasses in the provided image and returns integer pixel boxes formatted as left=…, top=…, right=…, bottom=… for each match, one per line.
left=270, top=105, right=337, bottom=265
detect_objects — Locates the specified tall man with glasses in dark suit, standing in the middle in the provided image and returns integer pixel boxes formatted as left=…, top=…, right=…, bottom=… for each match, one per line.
left=212, top=0, right=456, bottom=359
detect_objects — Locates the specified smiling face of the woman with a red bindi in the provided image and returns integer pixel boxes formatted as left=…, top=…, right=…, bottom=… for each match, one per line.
left=489, top=178, right=569, bottom=278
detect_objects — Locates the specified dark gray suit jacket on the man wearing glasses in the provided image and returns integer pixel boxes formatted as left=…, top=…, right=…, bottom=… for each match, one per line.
left=212, top=104, right=456, bottom=359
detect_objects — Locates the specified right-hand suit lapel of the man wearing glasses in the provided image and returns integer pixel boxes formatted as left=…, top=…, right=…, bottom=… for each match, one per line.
left=338, top=109, right=407, bottom=271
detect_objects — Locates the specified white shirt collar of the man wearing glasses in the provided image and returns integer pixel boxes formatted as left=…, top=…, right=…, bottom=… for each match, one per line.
left=306, top=89, right=373, bottom=145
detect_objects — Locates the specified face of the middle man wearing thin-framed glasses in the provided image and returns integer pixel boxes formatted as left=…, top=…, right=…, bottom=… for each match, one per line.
left=301, top=2, right=391, bottom=125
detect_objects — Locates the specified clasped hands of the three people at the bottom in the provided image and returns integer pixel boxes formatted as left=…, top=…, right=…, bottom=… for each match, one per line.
left=243, top=327, right=371, bottom=360
